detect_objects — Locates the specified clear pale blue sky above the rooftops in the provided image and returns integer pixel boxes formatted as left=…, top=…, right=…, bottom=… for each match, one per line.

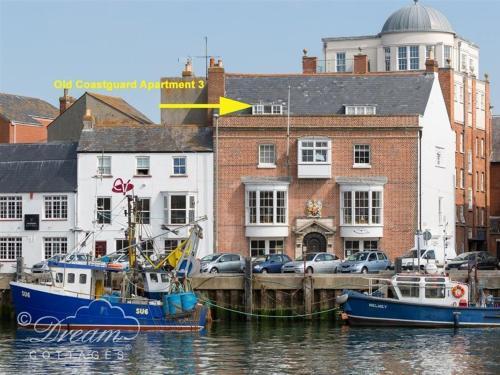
left=0, top=0, right=500, bottom=122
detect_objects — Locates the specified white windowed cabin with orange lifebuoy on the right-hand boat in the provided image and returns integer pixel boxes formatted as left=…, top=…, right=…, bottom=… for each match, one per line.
left=370, top=274, right=469, bottom=306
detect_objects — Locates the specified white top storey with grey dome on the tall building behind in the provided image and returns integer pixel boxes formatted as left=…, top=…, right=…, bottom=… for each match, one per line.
left=322, top=1, right=479, bottom=76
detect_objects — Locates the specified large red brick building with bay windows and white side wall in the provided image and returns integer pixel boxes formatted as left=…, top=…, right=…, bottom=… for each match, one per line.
left=183, top=58, right=454, bottom=258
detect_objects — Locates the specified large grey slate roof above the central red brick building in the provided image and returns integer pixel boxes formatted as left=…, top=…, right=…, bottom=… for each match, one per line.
left=226, top=73, right=434, bottom=115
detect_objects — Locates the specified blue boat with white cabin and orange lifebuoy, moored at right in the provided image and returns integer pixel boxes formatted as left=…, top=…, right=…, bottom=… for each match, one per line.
left=337, top=274, right=500, bottom=327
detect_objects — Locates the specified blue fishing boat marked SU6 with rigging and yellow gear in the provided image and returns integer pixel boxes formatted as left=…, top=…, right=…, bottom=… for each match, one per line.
left=10, top=197, right=208, bottom=332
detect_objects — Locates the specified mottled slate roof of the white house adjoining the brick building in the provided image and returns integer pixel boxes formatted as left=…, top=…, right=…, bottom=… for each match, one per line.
left=78, top=125, right=212, bottom=152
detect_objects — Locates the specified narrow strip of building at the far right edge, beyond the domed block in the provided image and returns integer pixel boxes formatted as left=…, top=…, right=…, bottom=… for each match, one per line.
left=489, top=116, right=500, bottom=259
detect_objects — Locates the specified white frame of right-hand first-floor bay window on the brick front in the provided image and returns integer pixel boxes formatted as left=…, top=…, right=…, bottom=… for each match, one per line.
left=340, top=186, right=384, bottom=227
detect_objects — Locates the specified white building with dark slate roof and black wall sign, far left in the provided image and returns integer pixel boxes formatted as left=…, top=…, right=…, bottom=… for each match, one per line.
left=0, top=143, right=78, bottom=273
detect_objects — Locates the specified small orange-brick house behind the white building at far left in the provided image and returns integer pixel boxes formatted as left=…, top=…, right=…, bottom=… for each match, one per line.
left=0, top=93, right=58, bottom=143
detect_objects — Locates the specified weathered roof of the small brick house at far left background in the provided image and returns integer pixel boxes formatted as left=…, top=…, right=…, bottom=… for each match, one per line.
left=0, top=93, right=59, bottom=125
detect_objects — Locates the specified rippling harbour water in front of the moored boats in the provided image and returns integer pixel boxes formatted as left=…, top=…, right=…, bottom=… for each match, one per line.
left=0, top=321, right=500, bottom=374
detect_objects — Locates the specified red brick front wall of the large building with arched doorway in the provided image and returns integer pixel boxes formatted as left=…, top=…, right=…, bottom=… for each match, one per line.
left=217, top=116, right=418, bottom=258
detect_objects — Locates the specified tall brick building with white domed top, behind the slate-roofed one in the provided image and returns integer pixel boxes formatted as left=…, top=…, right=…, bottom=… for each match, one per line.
left=318, top=2, right=491, bottom=253
